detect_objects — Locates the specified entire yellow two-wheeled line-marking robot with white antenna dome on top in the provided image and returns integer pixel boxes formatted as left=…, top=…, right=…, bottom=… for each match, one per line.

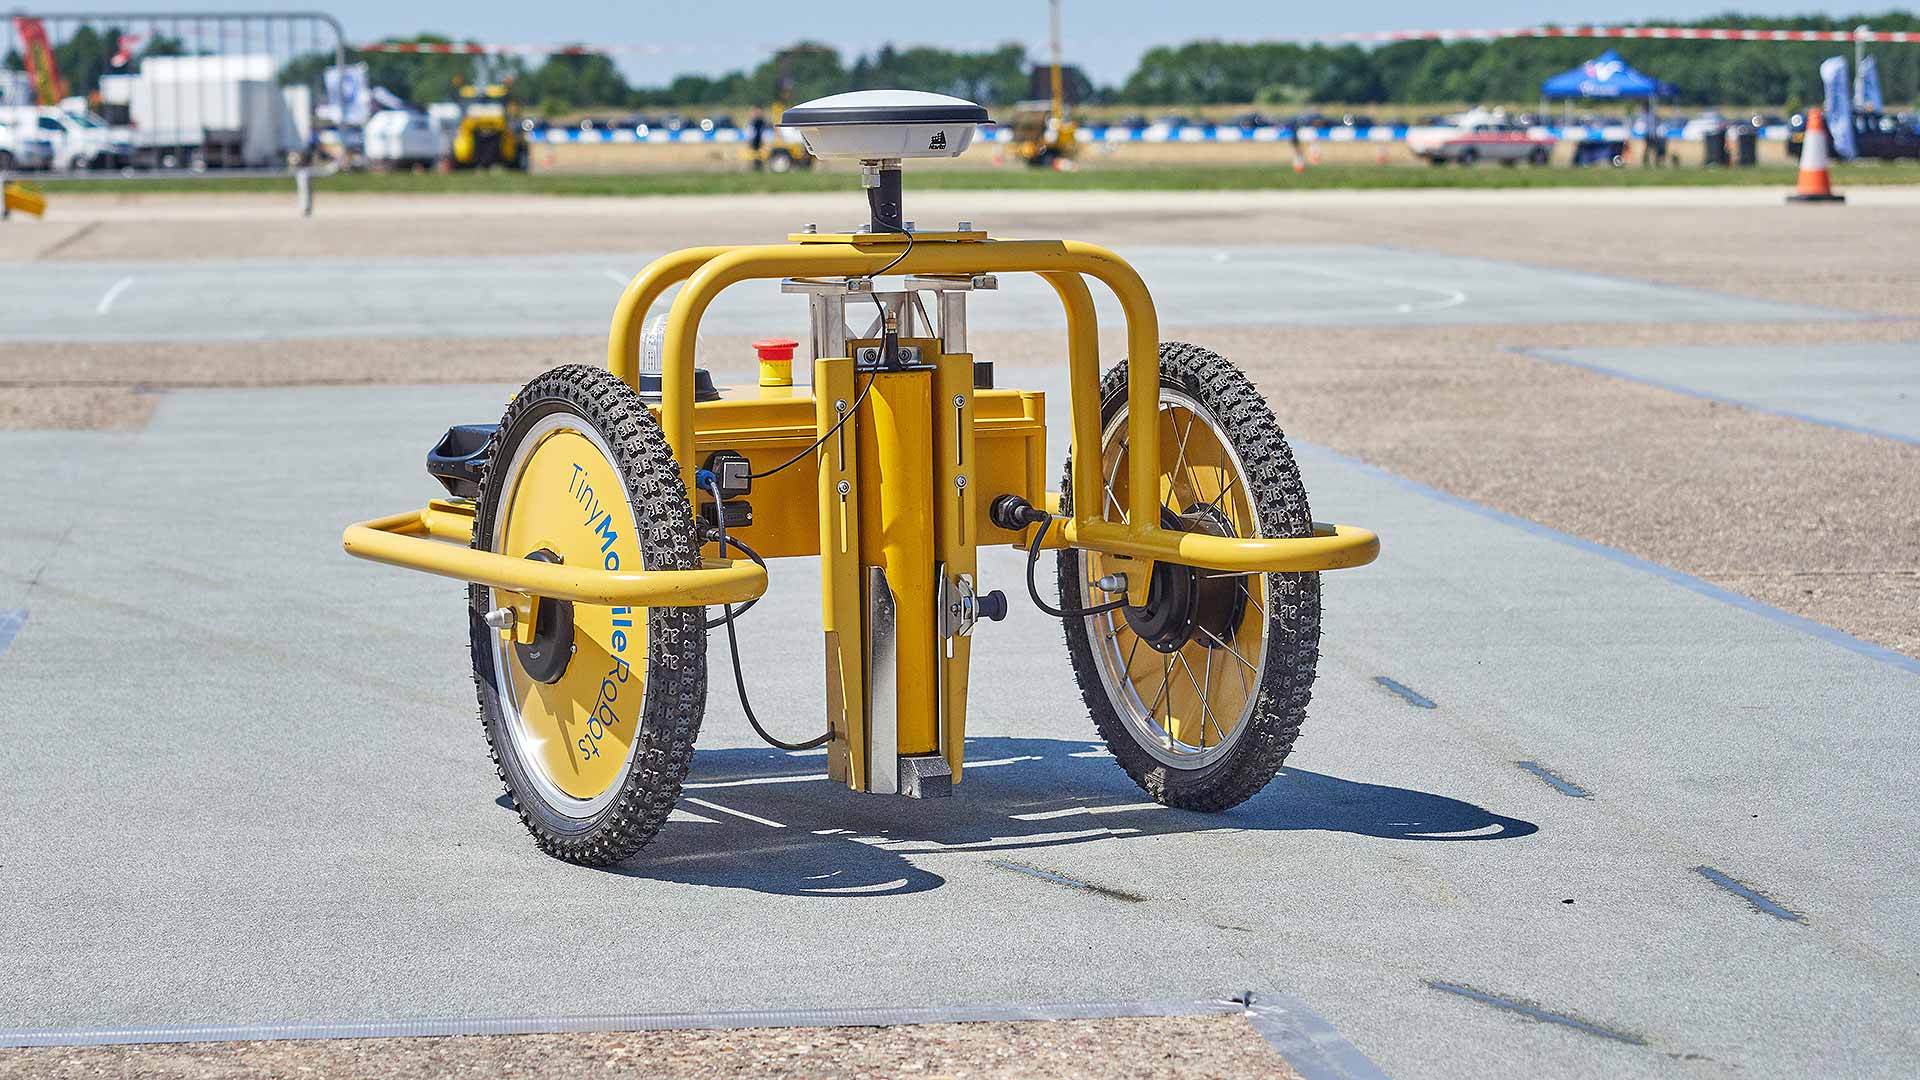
left=344, top=90, right=1379, bottom=865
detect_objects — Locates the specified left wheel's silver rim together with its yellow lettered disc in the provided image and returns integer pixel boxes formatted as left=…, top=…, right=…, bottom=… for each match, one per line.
left=492, top=411, right=647, bottom=819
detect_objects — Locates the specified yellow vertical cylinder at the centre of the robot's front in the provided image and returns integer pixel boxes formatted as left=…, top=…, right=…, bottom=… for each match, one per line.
left=852, top=371, right=941, bottom=755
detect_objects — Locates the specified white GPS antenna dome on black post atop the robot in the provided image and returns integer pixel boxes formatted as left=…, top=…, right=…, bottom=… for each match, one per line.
left=780, top=90, right=993, bottom=233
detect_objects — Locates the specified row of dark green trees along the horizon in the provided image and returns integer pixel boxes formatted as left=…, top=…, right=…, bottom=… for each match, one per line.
left=6, top=12, right=1920, bottom=113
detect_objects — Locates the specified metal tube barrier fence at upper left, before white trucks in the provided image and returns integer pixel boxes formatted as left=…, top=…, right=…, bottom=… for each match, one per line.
left=0, top=12, right=347, bottom=191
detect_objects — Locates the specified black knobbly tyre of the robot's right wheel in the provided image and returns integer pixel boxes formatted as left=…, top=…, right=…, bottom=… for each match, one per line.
left=1058, top=342, right=1321, bottom=813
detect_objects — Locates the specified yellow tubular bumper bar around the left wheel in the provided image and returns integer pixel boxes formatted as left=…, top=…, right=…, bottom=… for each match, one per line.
left=340, top=500, right=766, bottom=607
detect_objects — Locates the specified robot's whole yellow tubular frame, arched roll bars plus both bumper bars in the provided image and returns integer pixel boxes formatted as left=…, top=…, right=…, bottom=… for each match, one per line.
left=342, top=236, right=1380, bottom=607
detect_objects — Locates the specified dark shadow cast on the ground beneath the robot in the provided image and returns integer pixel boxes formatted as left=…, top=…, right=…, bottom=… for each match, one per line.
left=576, top=738, right=1540, bottom=897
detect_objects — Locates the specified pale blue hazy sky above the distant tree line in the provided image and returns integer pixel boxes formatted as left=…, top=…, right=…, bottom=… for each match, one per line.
left=74, top=0, right=1857, bottom=83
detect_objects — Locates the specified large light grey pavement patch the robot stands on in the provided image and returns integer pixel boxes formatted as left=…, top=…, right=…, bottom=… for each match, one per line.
left=0, top=371, right=1920, bottom=1076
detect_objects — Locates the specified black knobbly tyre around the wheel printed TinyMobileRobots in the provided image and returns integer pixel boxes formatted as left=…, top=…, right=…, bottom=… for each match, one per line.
left=468, top=363, right=707, bottom=867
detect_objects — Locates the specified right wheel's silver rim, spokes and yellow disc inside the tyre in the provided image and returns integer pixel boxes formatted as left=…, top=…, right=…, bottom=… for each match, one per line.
left=1079, top=384, right=1269, bottom=769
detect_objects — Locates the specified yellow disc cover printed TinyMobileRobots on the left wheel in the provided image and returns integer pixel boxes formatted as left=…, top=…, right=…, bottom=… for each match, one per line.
left=493, top=429, right=647, bottom=799
